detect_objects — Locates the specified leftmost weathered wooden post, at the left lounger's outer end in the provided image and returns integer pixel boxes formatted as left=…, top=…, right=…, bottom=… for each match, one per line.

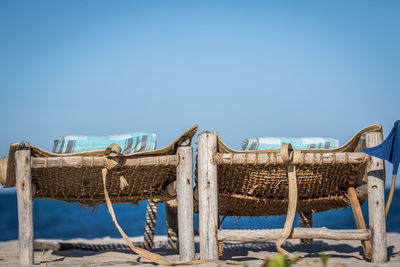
left=15, top=150, right=33, bottom=265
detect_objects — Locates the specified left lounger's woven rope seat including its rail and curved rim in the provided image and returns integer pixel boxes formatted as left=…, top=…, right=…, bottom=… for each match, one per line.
left=3, top=125, right=197, bottom=206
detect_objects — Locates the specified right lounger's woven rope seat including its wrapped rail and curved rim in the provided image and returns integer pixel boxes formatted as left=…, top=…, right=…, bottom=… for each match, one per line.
left=195, top=124, right=382, bottom=216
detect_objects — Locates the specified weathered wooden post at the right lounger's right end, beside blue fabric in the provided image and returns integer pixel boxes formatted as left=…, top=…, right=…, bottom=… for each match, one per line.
left=365, top=132, right=387, bottom=263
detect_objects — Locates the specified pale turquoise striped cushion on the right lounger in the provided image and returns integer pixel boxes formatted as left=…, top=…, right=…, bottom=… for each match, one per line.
left=242, top=137, right=339, bottom=150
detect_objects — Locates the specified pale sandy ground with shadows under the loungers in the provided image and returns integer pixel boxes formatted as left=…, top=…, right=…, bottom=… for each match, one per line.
left=0, top=233, right=400, bottom=267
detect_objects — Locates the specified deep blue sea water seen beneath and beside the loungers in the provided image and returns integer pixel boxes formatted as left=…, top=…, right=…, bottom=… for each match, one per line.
left=0, top=190, right=400, bottom=241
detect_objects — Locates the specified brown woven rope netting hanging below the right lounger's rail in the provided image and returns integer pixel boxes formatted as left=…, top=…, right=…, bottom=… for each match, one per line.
left=217, top=163, right=365, bottom=216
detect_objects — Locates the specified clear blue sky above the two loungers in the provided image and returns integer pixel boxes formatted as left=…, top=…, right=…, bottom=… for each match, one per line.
left=0, top=1, right=400, bottom=191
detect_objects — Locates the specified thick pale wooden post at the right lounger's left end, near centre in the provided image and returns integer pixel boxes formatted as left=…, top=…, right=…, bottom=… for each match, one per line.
left=198, top=132, right=218, bottom=260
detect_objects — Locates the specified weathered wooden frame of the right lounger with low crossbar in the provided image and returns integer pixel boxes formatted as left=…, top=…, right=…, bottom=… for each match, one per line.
left=197, top=125, right=388, bottom=263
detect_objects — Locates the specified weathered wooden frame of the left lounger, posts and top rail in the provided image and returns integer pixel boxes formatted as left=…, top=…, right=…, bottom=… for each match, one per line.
left=2, top=125, right=197, bottom=265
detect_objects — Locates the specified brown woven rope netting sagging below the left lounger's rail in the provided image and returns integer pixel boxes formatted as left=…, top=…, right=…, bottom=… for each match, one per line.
left=32, top=165, right=176, bottom=205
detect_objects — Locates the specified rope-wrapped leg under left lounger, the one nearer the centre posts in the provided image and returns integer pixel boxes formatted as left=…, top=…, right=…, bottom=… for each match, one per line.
left=165, top=200, right=178, bottom=249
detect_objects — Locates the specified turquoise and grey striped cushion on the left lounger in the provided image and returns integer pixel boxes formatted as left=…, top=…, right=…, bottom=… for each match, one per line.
left=53, top=133, right=156, bottom=154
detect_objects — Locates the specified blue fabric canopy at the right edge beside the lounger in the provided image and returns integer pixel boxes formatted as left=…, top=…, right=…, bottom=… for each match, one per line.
left=361, top=120, right=400, bottom=175
